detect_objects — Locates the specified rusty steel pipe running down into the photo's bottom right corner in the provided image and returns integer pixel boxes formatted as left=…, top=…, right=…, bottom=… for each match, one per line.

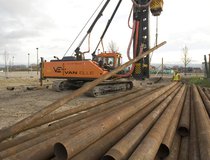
left=192, top=85, right=210, bottom=160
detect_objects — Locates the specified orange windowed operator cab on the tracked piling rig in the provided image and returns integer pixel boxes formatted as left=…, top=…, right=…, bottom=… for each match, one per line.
left=96, top=52, right=122, bottom=70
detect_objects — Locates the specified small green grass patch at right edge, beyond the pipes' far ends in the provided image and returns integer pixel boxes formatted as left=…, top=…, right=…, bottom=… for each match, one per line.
left=189, top=77, right=210, bottom=88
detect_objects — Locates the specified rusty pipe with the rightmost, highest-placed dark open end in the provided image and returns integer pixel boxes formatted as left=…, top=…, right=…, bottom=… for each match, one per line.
left=177, top=86, right=191, bottom=136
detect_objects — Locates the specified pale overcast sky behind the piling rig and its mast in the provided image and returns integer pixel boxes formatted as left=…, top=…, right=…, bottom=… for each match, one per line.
left=0, top=0, right=210, bottom=64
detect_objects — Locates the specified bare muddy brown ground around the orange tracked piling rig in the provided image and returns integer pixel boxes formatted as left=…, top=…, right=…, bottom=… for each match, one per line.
left=0, top=72, right=170, bottom=129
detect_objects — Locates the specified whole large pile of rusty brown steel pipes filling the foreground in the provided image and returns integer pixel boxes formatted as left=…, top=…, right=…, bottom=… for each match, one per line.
left=0, top=83, right=210, bottom=160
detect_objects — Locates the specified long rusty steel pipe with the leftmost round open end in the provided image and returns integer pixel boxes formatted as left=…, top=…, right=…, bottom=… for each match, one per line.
left=54, top=84, right=175, bottom=159
